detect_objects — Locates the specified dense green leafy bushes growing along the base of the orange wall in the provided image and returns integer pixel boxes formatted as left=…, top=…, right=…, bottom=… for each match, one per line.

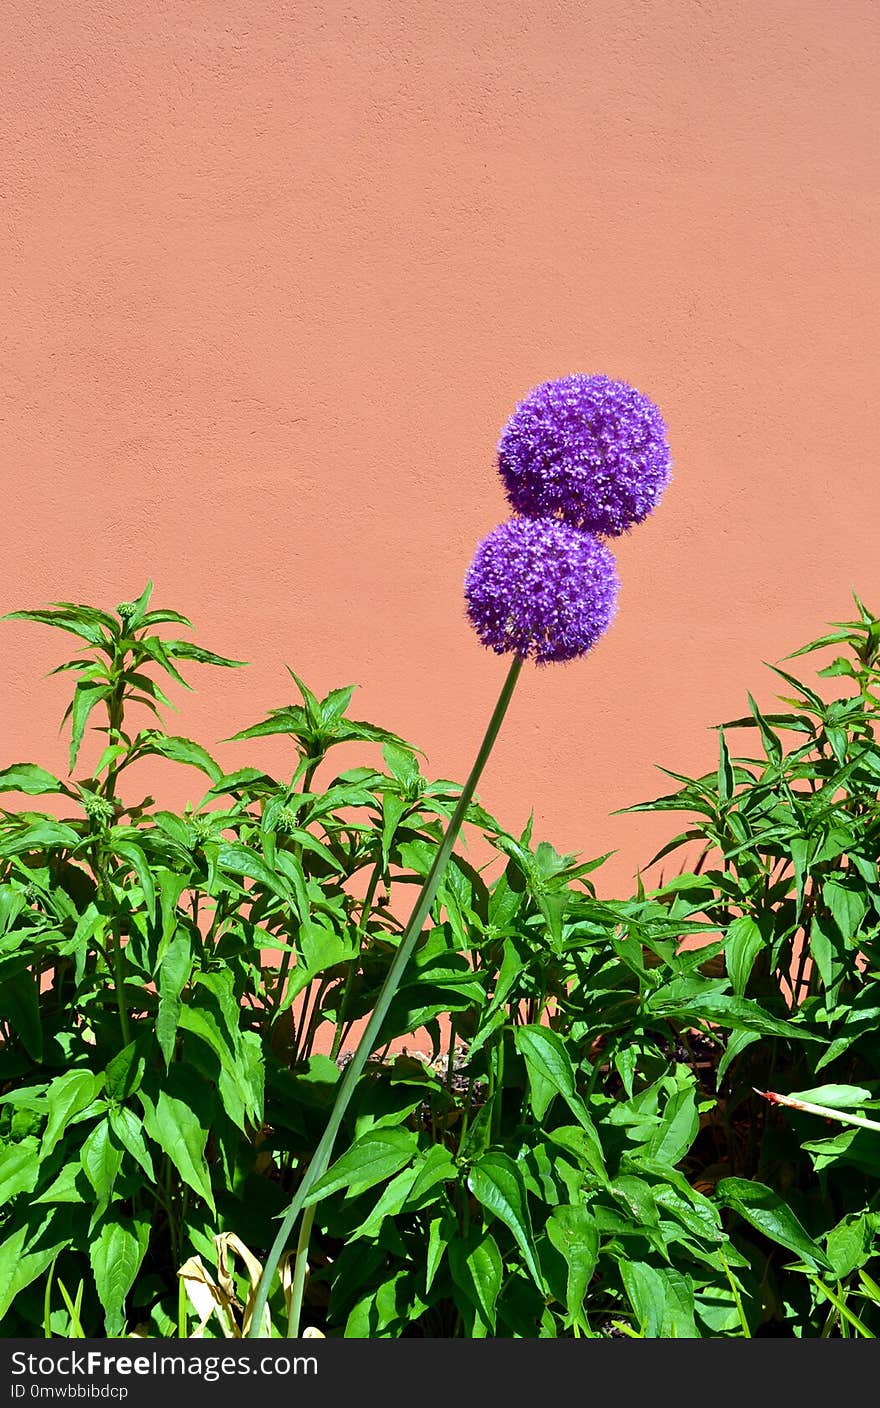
left=0, top=587, right=880, bottom=1338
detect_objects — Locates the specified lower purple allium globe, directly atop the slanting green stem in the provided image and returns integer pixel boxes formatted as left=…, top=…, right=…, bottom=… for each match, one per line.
left=465, top=518, right=617, bottom=665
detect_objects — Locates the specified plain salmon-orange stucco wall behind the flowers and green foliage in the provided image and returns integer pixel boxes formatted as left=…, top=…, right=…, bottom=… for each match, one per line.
left=0, top=0, right=880, bottom=888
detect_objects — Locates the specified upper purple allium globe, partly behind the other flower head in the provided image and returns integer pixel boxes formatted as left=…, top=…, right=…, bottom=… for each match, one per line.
left=498, top=375, right=670, bottom=538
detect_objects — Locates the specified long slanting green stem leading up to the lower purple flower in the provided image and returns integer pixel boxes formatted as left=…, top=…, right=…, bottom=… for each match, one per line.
left=249, top=656, right=522, bottom=1339
